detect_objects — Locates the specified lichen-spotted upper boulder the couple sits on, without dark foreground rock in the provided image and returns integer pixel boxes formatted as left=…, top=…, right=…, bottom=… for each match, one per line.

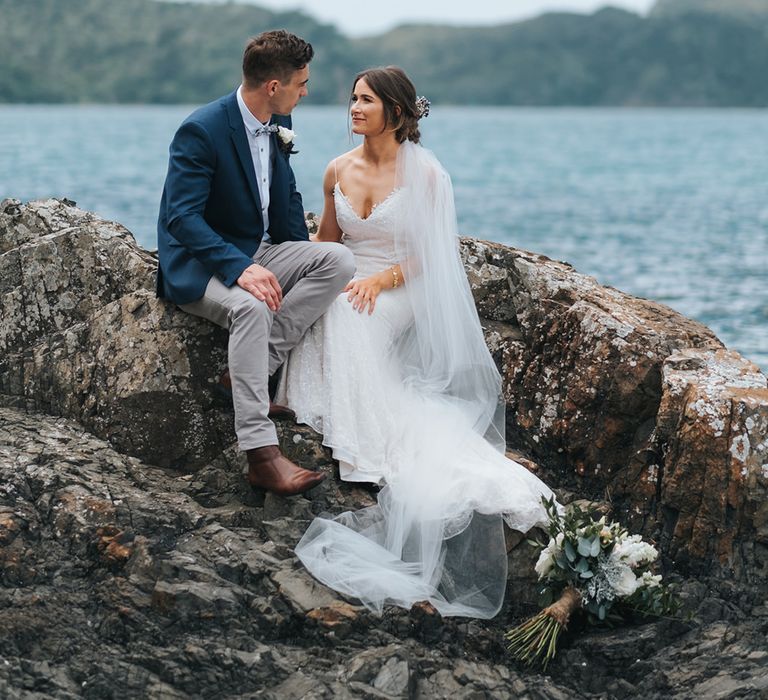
left=0, top=200, right=768, bottom=580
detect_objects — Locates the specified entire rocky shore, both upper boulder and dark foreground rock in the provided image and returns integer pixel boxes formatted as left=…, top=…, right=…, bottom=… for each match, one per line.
left=0, top=200, right=768, bottom=698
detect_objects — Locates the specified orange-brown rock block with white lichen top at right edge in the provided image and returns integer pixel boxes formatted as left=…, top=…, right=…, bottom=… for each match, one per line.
left=655, top=350, right=768, bottom=580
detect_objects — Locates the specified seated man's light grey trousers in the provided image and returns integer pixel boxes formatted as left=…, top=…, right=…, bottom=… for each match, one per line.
left=181, top=241, right=354, bottom=450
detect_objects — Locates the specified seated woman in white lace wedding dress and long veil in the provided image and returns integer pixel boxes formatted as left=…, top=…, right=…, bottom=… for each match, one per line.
left=276, top=67, right=552, bottom=618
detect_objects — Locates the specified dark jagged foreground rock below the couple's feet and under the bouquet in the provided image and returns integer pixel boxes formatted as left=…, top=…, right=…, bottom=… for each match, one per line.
left=0, top=408, right=768, bottom=700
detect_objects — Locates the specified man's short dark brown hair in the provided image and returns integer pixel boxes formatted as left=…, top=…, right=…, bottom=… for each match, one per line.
left=243, top=29, right=315, bottom=87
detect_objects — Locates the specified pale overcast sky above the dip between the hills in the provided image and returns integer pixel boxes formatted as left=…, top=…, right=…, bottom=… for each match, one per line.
left=251, top=0, right=654, bottom=36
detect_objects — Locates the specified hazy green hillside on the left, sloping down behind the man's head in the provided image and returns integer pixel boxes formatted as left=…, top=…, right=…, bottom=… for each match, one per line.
left=0, top=0, right=358, bottom=103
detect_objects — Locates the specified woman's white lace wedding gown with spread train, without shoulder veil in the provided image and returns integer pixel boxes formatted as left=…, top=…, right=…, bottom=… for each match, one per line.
left=277, top=144, right=552, bottom=617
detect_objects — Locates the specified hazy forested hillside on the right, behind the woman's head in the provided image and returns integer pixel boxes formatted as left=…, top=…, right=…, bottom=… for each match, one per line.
left=358, top=8, right=768, bottom=106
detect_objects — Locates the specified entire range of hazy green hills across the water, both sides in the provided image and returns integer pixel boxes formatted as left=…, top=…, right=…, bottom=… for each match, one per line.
left=0, top=0, right=768, bottom=106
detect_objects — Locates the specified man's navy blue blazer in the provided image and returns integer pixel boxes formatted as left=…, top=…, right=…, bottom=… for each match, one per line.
left=157, top=92, right=308, bottom=304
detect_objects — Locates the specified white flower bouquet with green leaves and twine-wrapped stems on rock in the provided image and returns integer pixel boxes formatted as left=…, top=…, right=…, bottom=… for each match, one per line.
left=506, top=498, right=677, bottom=669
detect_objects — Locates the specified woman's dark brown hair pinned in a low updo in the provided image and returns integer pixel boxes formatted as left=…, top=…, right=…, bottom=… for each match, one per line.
left=352, top=66, right=421, bottom=143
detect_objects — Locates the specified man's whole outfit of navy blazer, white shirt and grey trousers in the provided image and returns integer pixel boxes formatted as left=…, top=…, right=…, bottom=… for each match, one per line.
left=157, top=90, right=354, bottom=450
